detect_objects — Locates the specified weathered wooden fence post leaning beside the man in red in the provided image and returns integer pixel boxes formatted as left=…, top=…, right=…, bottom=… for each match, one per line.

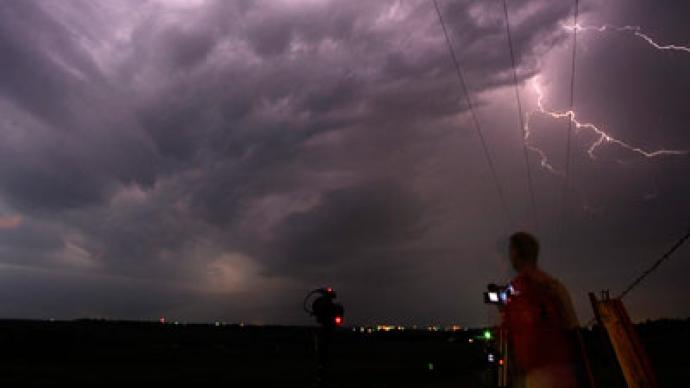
left=589, top=292, right=657, bottom=388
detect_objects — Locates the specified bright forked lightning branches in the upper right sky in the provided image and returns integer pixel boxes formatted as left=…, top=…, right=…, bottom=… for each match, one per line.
left=523, top=24, right=690, bottom=175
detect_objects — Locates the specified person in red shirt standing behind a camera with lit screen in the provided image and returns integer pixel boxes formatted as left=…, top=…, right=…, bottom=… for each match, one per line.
left=502, top=232, right=579, bottom=388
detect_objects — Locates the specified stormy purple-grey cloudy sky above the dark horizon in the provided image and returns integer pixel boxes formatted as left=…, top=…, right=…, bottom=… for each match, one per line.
left=0, top=0, right=690, bottom=325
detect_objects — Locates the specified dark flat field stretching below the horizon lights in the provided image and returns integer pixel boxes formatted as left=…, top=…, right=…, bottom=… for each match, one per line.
left=0, top=321, right=690, bottom=388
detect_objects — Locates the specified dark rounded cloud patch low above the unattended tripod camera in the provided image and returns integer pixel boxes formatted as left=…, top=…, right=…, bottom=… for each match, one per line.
left=260, top=182, right=425, bottom=282
